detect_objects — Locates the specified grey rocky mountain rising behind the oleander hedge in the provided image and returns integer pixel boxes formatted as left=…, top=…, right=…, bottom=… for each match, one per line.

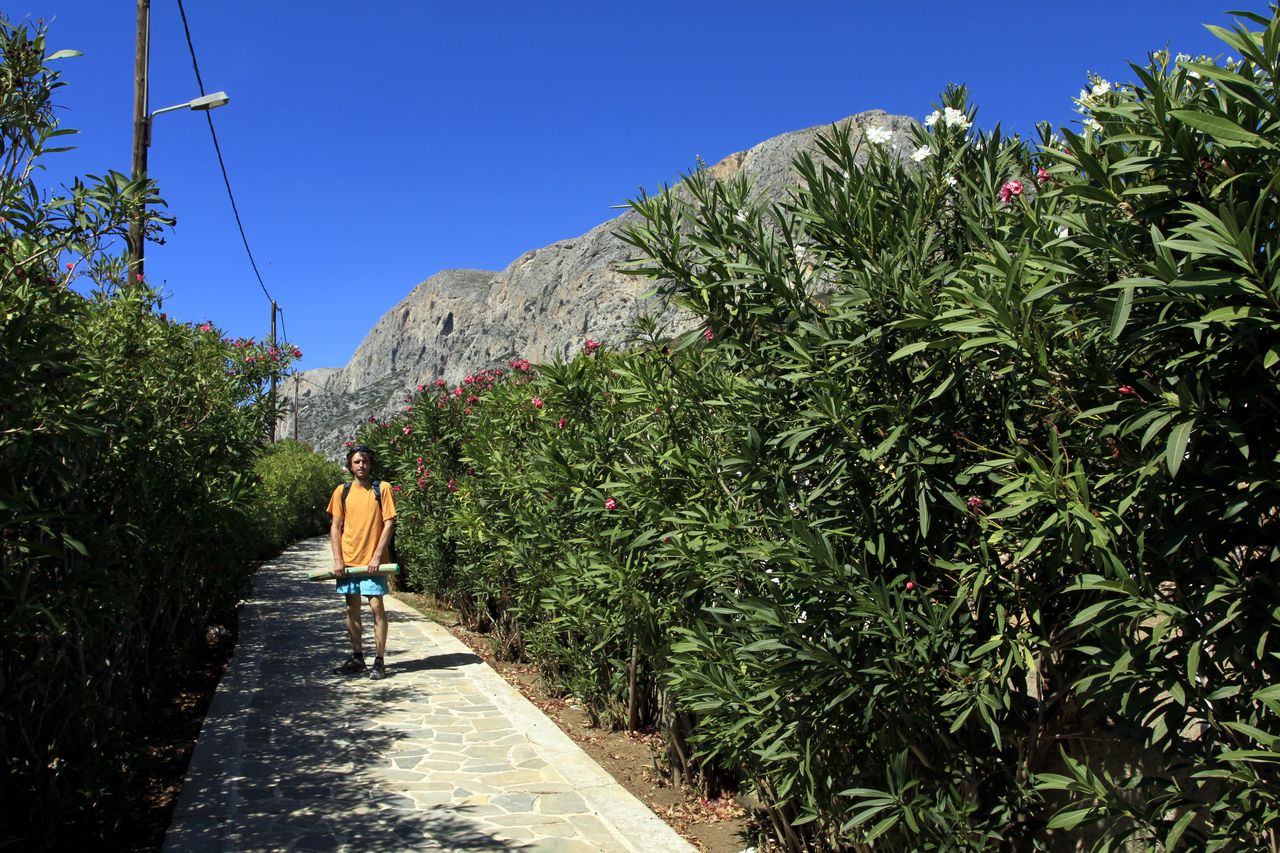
left=279, top=110, right=915, bottom=457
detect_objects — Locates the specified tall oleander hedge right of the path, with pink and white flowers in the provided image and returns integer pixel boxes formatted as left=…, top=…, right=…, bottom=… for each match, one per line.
left=365, top=6, right=1280, bottom=850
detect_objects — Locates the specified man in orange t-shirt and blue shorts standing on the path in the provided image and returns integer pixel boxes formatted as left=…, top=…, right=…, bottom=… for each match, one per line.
left=328, top=444, right=396, bottom=679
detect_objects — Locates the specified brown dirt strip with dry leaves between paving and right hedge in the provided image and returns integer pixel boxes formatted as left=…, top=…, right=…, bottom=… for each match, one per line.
left=393, top=592, right=750, bottom=853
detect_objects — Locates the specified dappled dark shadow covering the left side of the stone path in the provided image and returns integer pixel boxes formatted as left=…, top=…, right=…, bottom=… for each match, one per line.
left=165, top=539, right=527, bottom=852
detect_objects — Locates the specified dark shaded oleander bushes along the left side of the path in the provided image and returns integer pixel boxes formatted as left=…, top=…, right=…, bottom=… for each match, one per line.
left=0, top=19, right=317, bottom=849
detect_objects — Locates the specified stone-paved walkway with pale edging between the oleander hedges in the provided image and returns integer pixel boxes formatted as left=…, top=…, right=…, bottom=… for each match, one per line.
left=164, top=539, right=692, bottom=853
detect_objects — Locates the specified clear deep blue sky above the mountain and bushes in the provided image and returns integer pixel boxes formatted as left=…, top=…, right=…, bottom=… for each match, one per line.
left=5, top=0, right=1266, bottom=368
